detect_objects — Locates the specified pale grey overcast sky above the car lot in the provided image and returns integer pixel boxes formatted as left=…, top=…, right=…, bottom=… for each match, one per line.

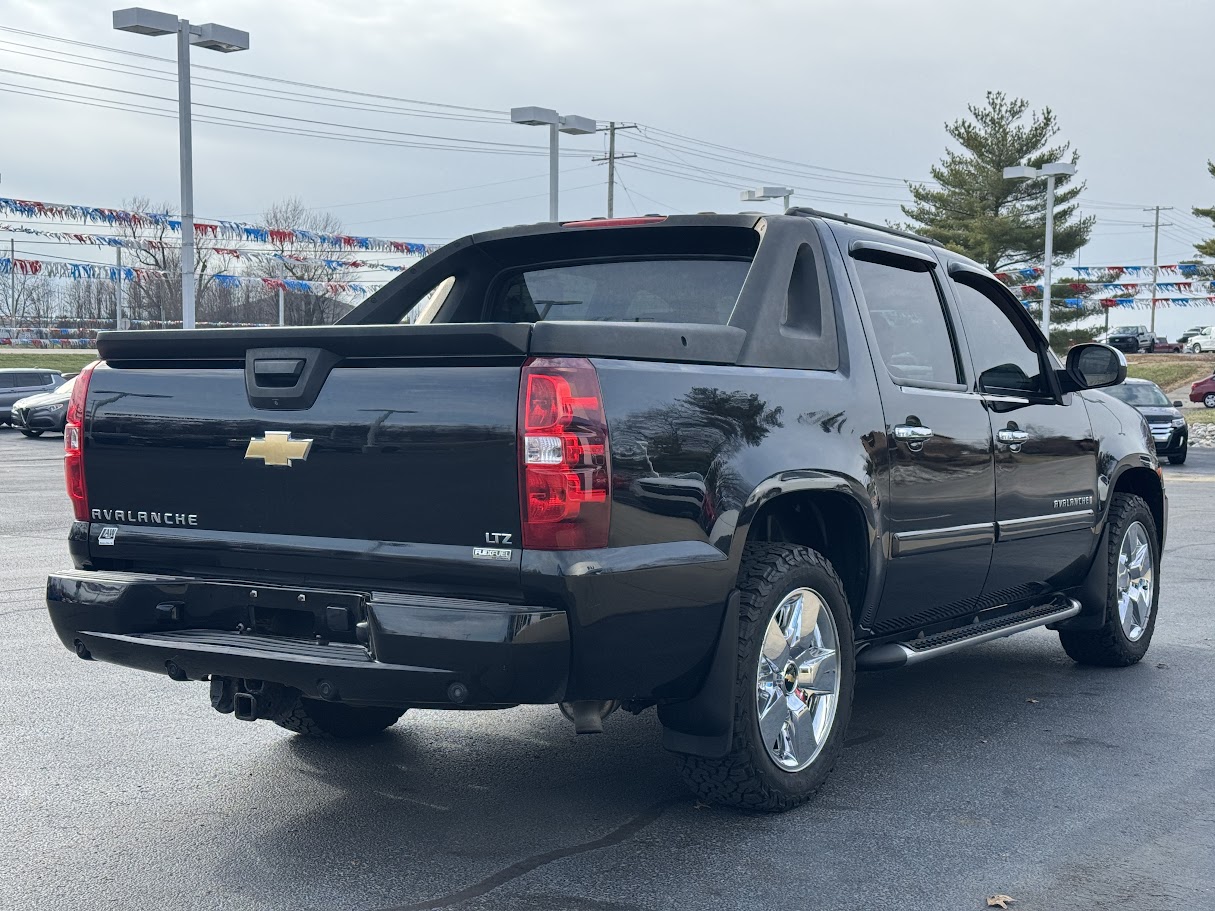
left=0, top=0, right=1215, bottom=332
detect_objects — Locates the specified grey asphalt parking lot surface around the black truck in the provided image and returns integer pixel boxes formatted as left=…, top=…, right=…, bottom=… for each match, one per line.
left=0, top=428, right=1215, bottom=911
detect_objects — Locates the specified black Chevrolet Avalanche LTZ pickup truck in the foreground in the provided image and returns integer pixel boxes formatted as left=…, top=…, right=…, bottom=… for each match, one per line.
left=46, top=209, right=1168, bottom=810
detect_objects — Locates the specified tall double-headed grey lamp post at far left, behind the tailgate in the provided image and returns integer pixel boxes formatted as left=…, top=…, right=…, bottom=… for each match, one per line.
left=114, top=6, right=249, bottom=329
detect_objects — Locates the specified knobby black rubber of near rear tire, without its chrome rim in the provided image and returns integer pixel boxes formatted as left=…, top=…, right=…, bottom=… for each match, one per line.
left=676, top=543, right=852, bottom=813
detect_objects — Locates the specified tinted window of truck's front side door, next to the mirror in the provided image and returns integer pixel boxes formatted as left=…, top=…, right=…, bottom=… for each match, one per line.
left=954, top=278, right=1051, bottom=396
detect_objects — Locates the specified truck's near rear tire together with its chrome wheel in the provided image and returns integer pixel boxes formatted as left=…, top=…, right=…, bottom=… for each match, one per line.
left=677, top=544, right=855, bottom=813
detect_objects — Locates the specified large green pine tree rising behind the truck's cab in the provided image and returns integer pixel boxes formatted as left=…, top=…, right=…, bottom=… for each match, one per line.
left=903, top=91, right=1096, bottom=273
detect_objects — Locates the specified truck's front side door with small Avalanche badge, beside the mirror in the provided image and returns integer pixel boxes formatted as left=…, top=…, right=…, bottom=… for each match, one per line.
left=948, top=262, right=1097, bottom=602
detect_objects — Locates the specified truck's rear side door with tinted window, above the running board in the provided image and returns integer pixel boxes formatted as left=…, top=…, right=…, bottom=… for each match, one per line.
left=832, top=225, right=995, bottom=634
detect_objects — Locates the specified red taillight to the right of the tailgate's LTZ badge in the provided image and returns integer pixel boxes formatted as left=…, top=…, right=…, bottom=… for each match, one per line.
left=519, top=357, right=611, bottom=550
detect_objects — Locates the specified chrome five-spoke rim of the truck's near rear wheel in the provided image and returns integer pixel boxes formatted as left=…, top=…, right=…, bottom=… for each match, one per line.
left=756, top=587, right=840, bottom=771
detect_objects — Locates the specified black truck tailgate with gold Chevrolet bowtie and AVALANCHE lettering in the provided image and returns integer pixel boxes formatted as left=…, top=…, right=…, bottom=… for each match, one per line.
left=85, top=327, right=526, bottom=595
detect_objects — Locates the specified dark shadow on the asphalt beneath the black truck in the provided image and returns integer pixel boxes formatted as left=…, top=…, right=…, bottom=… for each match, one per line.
left=199, top=633, right=1209, bottom=910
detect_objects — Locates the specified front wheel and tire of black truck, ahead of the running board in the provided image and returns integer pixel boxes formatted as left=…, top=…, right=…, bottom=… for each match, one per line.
left=1059, top=493, right=1160, bottom=667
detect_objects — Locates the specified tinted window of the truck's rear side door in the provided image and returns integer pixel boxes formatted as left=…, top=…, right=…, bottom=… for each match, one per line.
left=855, top=258, right=961, bottom=385
